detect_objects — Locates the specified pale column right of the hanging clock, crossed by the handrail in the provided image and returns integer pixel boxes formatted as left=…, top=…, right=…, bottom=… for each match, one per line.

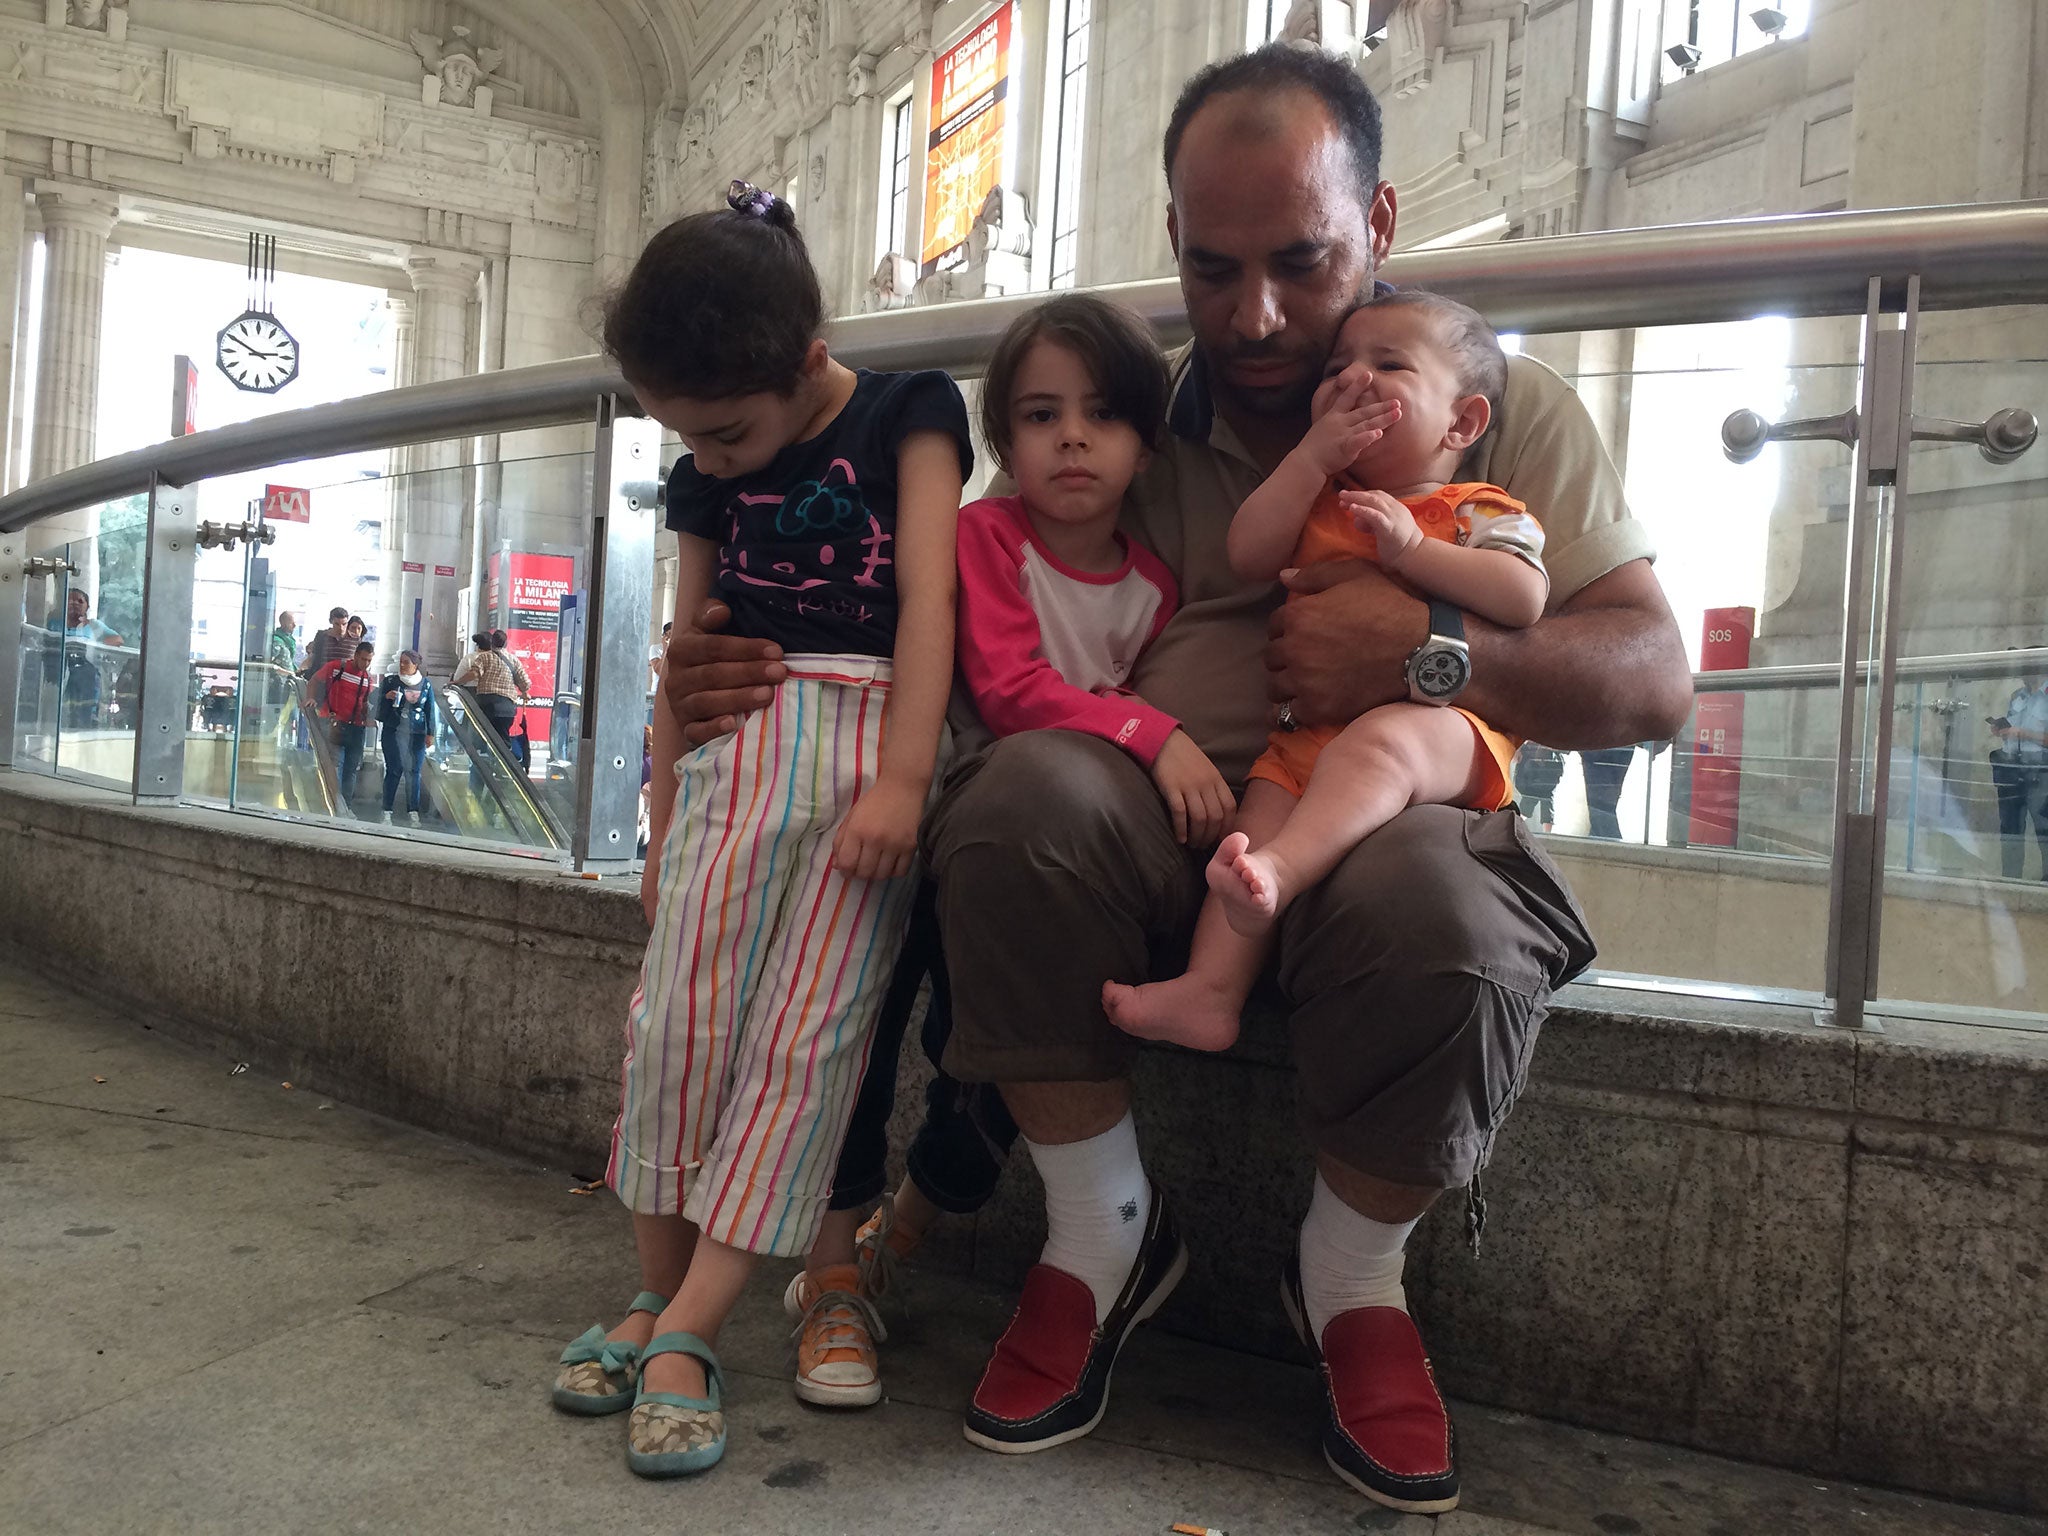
left=379, top=252, right=485, bottom=678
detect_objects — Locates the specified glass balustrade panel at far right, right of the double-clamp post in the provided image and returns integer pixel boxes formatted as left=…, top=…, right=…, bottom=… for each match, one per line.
left=1878, top=307, right=2048, bottom=1026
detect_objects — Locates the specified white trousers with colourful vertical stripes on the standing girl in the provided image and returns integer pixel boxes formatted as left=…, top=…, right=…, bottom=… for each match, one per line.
left=604, top=655, right=915, bottom=1255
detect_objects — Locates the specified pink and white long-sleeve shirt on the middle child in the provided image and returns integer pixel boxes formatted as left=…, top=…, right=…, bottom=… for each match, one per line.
left=958, top=496, right=1180, bottom=768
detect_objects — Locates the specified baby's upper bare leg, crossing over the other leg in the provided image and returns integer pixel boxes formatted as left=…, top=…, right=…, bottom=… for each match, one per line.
left=1208, top=705, right=1489, bottom=934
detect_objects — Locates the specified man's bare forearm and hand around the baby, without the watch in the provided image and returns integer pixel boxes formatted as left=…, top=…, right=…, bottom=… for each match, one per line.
left=1266, top=559, right=1692, bottom=752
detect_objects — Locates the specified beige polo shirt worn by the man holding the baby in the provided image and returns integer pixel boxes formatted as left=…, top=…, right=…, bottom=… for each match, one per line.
left=1122, top=344, right=1655, bottom=784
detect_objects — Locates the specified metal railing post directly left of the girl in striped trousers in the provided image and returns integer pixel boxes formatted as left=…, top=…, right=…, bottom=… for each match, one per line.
left=571, top=395, right=662, bottom=872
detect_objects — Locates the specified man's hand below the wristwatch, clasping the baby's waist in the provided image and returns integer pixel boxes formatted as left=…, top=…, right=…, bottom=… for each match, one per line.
left=1266, top=559, right=1430, bottom=727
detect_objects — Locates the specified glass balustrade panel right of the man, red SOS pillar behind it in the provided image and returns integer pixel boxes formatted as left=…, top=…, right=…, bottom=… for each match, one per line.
left=1509, top=317, right=1862, bottom=993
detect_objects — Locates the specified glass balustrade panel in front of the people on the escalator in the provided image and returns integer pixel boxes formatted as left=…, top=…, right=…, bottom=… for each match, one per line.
left=200, top=438, right=590, bottom=856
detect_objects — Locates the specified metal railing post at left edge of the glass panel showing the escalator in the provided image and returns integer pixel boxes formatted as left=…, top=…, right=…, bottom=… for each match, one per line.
left=135, top=479, right=199, bottom=805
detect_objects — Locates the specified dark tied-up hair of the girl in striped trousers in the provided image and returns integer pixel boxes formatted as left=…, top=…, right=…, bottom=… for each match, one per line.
left=604, top=182, right=825, bottom=399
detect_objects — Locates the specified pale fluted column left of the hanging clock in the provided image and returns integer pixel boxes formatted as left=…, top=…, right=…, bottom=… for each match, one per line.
left=29, top=182, right=119, bottom=479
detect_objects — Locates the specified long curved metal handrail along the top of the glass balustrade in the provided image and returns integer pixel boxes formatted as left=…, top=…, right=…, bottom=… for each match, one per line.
left=0, top=201, right=2048, bottom=532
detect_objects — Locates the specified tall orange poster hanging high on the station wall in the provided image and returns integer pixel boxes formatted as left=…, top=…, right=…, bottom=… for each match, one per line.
left=920, top=4, right=1016, bottom=276
